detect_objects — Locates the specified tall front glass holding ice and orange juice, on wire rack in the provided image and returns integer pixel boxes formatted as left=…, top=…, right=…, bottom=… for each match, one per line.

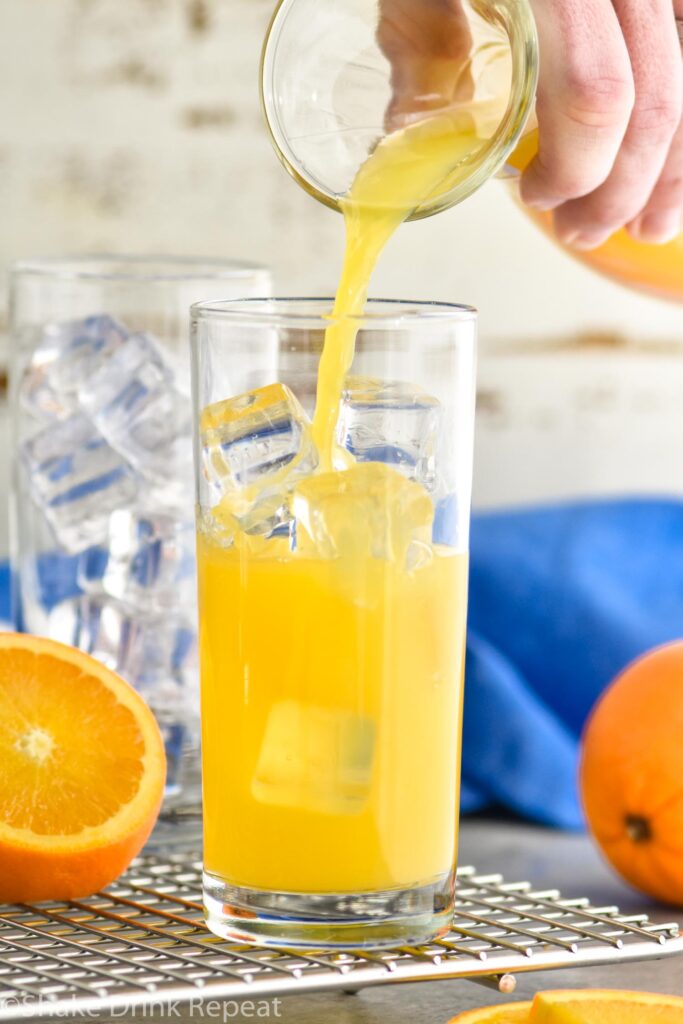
left=191, top=299, right=476, bottom=947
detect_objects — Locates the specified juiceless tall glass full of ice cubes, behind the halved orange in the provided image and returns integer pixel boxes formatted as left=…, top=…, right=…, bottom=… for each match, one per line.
left=11, top=257, right=269, bottom=802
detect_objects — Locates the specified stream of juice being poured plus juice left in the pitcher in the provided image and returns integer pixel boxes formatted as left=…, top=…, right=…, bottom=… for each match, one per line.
left=313, top=114, right=683, bottom=395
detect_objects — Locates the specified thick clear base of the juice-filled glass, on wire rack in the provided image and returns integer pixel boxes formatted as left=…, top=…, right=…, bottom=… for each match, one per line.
left=204, top=871, right=455, bottom=949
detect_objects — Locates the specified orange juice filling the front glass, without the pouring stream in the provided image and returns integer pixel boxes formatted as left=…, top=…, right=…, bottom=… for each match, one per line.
left=199, top=537, right=467, bottom=893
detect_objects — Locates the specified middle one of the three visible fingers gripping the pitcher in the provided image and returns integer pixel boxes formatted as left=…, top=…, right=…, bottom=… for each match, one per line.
left=555, top=0, right=683, bottom=249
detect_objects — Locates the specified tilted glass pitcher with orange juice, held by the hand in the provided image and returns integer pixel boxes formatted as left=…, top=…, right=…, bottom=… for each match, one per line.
left=262, top=0, right=683, bottom=301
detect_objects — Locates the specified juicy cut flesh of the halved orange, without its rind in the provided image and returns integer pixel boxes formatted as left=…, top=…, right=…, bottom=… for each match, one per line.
left=0, top=648, right=144, bottom=836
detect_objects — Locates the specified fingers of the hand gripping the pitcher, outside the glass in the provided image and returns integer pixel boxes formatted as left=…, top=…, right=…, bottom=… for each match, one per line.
left=520, top=0, right=683, bottom=249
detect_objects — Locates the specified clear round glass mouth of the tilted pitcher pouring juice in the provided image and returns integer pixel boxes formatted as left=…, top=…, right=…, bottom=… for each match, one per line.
left=261, top=0, right=538, bottom=219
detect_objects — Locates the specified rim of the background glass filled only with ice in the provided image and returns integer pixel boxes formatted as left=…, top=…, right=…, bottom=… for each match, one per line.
left=9, top=253, right=269, bottom=283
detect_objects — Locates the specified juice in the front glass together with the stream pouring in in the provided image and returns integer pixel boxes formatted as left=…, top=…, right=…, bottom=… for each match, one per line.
left=198, top=115, right=480, bottom=893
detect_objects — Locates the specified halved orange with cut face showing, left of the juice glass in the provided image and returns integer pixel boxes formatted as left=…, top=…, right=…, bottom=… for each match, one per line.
left=0, top=633, right=166, bottom=903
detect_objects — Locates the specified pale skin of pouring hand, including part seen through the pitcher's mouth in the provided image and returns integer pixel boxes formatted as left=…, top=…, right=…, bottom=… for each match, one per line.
left=378, top=0, right=683, bottom=249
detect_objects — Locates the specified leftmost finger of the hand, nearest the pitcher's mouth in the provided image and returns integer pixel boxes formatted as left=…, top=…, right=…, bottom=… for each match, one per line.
left=520, top=0, right=634, bottom=210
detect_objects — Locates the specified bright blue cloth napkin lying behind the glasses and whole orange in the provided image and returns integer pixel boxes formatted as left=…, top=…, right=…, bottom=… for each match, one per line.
left=6, top=499, right=683, bottom=828
